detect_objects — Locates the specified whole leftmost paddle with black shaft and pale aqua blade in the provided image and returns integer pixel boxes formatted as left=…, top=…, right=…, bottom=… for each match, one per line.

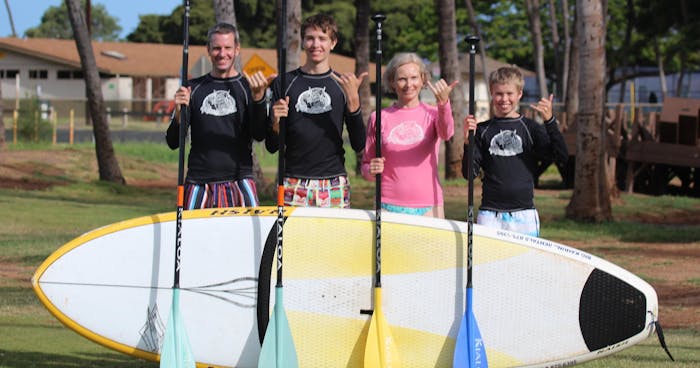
left=160, top=0, right=195, bottom=368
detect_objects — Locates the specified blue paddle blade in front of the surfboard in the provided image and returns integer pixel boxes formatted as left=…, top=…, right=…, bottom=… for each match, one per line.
left=452, top=288, right=489, bottom=368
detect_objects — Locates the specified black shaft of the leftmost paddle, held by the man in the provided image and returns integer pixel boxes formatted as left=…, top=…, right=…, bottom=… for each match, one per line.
left=173, top=0, right=190, bottom=288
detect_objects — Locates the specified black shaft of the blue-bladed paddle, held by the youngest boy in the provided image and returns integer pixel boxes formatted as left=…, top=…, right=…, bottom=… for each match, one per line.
left=467, top=36, right=479, bottom=288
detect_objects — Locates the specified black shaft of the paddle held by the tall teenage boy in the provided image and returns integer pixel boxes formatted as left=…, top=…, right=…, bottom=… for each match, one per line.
left=276, top=0, right=287, bottom=287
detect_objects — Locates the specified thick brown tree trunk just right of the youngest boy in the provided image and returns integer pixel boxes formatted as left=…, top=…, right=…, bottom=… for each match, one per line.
left=566, top=0, right=612, bottom=222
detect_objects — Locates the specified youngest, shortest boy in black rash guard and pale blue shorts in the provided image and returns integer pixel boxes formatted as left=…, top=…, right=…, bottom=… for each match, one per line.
left=462, top=66, right=568, bottom=236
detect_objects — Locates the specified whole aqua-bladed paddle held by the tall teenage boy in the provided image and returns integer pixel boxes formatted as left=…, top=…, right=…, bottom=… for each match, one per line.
left=258, top=0, right=299, bottom=368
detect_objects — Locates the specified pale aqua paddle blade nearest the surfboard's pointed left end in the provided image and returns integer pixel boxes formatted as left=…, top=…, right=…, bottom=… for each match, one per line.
left=160, top=288, right=195, bottom=368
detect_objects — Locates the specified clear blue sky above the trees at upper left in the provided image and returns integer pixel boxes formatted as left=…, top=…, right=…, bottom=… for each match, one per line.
left=0, top=0, right=183, bottom=39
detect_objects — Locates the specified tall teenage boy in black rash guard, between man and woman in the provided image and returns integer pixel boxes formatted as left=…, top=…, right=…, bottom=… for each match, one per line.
left=265, top=14, right=367, bottom=208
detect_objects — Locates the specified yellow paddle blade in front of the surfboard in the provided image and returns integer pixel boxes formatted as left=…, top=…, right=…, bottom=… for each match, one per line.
left=364, top=287, right=401, bottom=368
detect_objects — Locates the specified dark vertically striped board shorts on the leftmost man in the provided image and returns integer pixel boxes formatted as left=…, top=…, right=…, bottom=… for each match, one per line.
left=184, top=178, right=260, bottom=210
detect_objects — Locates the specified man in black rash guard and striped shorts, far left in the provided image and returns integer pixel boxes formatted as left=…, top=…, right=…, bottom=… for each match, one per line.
left=166, top=23, right=269, bottom=210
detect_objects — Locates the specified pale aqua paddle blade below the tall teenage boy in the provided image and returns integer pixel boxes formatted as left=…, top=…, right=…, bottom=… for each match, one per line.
left=258, top=286, right=299, bottom=368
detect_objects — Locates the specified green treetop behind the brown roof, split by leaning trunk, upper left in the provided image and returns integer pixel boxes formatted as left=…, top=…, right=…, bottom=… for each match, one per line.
left=24, top=0, right=122, bottom=41
